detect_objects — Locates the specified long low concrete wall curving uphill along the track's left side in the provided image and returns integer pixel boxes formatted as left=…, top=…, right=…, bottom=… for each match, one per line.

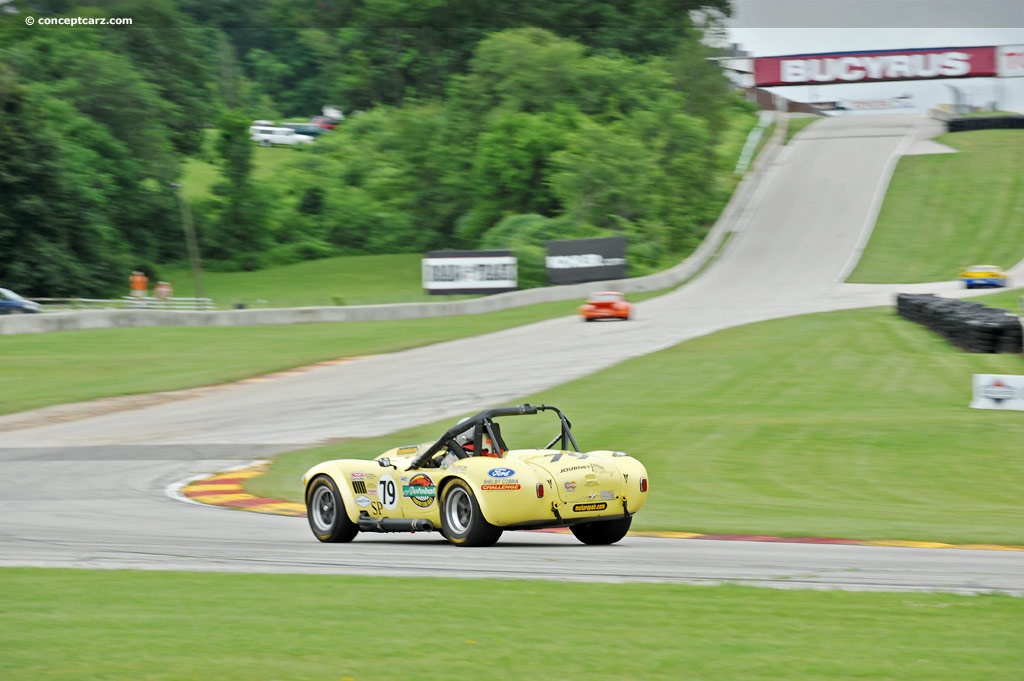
left=0, top=116, right=786, bottom=335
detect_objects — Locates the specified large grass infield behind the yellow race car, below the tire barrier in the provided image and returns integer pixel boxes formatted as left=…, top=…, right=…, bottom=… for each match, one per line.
left=250, top=308, right=1024, bottom=545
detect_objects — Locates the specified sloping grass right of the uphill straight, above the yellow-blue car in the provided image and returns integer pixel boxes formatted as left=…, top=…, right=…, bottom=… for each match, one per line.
left=849, top=130, right=1024, bottom=284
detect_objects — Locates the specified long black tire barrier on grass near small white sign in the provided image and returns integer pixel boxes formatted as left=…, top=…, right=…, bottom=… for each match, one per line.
left=896, top=293, right=1024, bottom=354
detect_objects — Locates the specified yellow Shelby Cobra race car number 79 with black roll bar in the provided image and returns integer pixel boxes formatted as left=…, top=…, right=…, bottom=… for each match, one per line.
left=302, top=405, right=647, bottom=546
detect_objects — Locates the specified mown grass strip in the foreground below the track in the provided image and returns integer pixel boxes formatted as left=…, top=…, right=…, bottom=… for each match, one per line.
left=0, top=569, right=1024, bottom=681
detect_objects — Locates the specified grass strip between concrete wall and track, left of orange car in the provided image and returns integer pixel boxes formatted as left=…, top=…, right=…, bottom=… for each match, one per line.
left=0, top=292, right=671, bottom=415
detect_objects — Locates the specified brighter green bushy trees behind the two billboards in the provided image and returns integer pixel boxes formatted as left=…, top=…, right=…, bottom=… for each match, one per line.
left=266, top=28, right=753, bottom=285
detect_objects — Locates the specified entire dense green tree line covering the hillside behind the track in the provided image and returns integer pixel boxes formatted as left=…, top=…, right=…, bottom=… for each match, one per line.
left=0, top=0, right=753, bottom=297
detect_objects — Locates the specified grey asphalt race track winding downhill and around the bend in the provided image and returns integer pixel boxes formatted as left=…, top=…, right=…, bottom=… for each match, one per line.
left=0, top=116, right=1024, bottom=595
